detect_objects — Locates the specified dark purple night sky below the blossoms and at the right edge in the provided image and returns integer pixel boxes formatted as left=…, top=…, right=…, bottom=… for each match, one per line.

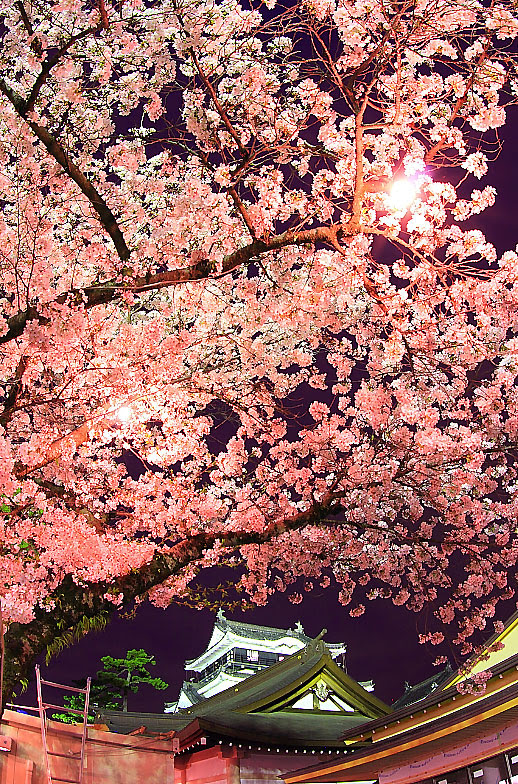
left=14, top=76, right=518, bottom=712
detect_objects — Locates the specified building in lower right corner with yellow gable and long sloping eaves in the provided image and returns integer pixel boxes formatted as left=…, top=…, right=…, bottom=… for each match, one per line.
left=283, top=613, right=518, bottom=784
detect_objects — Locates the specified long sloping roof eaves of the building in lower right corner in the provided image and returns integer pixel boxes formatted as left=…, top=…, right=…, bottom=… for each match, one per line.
left=284, top=656, right=518, bottom=784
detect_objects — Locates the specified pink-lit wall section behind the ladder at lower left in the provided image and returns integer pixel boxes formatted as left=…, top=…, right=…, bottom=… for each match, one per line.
left=0, top=710, right=174, bottom=784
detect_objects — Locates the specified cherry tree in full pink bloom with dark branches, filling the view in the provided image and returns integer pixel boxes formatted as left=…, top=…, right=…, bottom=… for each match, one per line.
left=0, top=0, right=518, bottom=694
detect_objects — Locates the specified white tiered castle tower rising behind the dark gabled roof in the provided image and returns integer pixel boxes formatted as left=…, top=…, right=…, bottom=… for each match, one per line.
left=164, top=609, right=373, bottom=713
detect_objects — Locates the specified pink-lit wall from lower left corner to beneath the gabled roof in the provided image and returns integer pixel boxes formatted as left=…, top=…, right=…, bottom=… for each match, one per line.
left=0, top=711, right=330, bottom=784
